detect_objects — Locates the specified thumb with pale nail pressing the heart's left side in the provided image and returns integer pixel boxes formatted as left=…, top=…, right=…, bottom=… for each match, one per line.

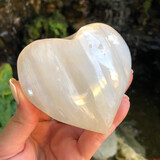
left=0, top=78, right=39, bottom=159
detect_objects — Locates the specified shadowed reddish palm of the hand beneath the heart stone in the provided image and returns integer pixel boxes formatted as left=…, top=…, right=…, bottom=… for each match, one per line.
left=26, top=121, right=83, bottom=160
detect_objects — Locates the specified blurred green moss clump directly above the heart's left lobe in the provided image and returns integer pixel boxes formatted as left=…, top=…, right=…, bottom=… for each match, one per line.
left=24, top=11, right=68, bottom=44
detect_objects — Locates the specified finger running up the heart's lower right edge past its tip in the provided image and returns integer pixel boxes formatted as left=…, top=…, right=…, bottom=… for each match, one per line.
left=78, top=96, right=130, bottom=159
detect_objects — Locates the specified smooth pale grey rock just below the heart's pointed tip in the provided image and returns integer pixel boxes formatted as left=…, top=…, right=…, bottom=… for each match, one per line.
left=93, top=132, right=117, bottom=160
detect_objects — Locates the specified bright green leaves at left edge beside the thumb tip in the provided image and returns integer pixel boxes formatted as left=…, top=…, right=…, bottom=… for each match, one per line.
left=0, top=63, right=16, bottom=132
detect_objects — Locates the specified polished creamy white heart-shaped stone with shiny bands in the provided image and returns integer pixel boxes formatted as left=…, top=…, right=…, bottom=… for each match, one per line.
left=18, top=23, right=131, bottom=133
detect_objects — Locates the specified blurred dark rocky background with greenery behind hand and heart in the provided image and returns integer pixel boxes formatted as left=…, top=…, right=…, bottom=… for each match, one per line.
left=0, top=0, right=160, bottom=160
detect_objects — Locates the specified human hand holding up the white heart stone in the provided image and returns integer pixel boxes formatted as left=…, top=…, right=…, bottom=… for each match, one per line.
left=0, top=74, right=133, bottom=160
